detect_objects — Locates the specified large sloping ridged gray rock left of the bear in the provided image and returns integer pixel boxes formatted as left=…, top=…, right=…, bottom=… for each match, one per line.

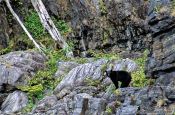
left=55, top=60, right=107, bottom=94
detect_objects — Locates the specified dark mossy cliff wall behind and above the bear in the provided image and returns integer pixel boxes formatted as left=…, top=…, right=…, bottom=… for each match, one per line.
left=16, top=0, right=148, bottom=55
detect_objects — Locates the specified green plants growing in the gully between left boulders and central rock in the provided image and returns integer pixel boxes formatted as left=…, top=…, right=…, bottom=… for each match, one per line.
left=17, top=50, right=68, bottom=113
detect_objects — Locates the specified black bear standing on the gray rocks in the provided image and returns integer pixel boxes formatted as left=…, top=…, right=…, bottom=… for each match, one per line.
left=106, top=70, right=131, bottom=89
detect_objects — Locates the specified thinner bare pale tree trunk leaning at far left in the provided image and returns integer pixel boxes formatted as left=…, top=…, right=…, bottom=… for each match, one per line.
left=5, top=0, right=43, bottom=53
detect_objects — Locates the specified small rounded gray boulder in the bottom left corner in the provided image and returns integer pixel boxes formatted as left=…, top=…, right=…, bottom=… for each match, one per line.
left=1, top=91, right=28, bottom=114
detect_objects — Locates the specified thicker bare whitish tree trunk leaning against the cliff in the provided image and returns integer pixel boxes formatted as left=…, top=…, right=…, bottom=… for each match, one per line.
left=31, top=0, right=73, bottom=57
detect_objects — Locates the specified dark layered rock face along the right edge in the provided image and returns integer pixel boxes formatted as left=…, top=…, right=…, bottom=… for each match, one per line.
left=146, top=0, right=175, bottom=82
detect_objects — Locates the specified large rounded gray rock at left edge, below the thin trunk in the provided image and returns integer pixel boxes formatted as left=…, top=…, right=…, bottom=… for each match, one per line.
left=0, top=51, right=46, bottom=92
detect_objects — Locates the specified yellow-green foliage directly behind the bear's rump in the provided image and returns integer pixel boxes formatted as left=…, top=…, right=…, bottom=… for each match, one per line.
left=132, top=50, right=148, bottom=87
